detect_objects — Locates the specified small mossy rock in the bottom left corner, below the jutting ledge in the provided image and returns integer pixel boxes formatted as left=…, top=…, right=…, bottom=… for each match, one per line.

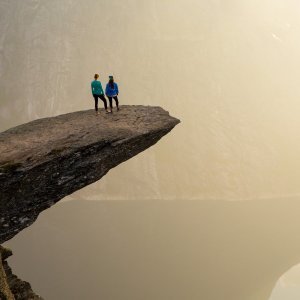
left=0, top=246, right=43, bottom=300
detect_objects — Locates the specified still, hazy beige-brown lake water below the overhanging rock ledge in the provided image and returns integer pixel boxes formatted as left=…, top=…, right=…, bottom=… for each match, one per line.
left=7, top=199, right=300, bottom=300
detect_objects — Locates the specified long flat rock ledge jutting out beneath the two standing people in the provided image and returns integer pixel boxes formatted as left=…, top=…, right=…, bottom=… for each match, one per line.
left=0, top=106, right=179, bottom=243
